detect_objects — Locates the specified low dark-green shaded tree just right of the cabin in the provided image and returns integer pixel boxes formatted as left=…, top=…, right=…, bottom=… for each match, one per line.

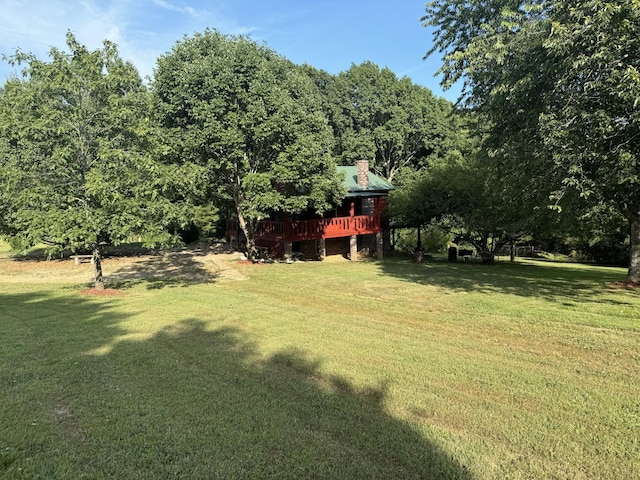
left=390, top=131, right=539, bottom=257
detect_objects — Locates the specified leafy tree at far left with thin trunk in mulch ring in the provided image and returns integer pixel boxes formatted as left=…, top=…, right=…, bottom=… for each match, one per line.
left=0, top=33, right=190, bottom=288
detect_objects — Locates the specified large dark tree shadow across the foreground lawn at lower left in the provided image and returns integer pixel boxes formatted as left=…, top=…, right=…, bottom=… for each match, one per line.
left=0, top=296, right=472, bottom=479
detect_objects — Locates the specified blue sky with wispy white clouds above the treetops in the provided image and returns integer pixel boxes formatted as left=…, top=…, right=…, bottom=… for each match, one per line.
left=0, top=0, right=459, bottom=101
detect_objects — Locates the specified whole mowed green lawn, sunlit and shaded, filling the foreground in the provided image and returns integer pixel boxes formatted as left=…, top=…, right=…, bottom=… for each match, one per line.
left=0, top=246, right=640, bottom=479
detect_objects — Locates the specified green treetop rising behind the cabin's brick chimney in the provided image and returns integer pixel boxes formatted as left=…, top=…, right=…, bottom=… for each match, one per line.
left=307, top=62, right=456, bottom=181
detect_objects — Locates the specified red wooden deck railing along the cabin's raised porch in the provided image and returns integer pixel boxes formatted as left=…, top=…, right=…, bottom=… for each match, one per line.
left=227, top=215, right=381, bottom=242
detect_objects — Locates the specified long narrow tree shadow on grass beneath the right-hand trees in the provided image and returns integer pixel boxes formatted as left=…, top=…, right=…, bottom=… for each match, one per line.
left=380, top=259, right=640, bottom=305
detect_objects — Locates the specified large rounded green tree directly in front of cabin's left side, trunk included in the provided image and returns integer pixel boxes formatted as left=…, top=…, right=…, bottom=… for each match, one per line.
left=153, top=30, right=343, bottom=258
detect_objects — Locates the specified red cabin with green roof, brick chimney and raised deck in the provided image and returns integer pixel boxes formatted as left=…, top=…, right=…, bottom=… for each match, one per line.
left=226, top=160, right=393, bottom=260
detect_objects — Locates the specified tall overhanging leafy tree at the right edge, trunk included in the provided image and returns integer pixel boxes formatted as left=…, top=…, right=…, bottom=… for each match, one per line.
left=424, top=0, right=640, bottom=282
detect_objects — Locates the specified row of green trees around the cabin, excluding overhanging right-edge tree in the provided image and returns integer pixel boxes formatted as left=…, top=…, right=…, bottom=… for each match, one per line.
left=0, top=24, right=636, bottom=288
